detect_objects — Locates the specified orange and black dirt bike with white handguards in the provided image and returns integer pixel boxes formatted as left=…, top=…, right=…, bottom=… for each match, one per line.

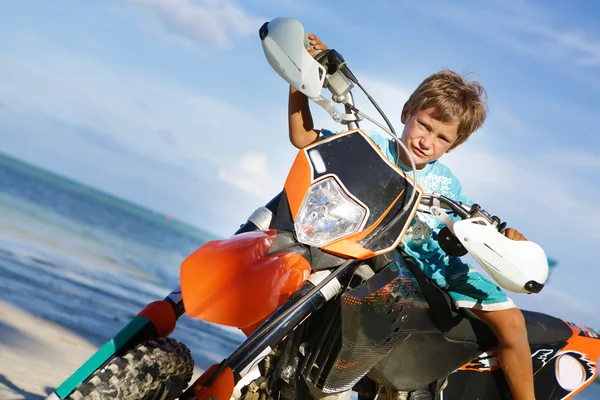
left=47, top=19, right=600, bottom=400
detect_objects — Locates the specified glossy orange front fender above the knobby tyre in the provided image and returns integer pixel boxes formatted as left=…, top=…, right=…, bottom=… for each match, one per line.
left=181, top=230, right=311, bottom=329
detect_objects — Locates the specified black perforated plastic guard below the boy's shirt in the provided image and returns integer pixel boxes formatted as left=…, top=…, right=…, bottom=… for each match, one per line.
left=323, top=253, right=437, bottom=393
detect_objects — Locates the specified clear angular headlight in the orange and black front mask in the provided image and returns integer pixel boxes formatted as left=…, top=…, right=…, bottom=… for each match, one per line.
left=294, top=177, right=367, bottom=247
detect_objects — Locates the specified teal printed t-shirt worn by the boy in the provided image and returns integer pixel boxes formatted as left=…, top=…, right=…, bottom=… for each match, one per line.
left=321, top=130, right=473, bottom=287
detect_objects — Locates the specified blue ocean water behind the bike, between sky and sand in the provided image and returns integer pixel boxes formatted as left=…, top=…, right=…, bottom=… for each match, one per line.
left=0, top=155, right=600, bottom=400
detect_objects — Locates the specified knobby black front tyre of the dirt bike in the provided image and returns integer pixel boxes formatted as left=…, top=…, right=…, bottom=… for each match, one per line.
left=68, top=338, right=194, bottom=400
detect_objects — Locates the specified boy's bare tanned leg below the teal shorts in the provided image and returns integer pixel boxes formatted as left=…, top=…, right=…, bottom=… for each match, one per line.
left=470, top=308, right=535, bottom=400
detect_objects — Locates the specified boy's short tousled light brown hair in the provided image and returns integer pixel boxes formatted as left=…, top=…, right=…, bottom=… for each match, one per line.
left=406, top=69, right=487, bottom=149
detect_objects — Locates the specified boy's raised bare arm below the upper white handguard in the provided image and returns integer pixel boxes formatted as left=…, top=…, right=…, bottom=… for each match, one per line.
left=288, top=86, right=320, bottom=149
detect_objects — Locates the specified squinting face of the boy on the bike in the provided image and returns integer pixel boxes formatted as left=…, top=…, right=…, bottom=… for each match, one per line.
left=400, top=104, right=459, bottom=169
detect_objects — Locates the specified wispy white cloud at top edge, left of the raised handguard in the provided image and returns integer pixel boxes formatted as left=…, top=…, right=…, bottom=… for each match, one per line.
left=123, top=0, right=265, bottom=47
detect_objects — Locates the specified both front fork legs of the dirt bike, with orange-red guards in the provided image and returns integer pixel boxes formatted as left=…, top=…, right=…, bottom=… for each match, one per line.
left=46, top=268, right=337, bottom=400
